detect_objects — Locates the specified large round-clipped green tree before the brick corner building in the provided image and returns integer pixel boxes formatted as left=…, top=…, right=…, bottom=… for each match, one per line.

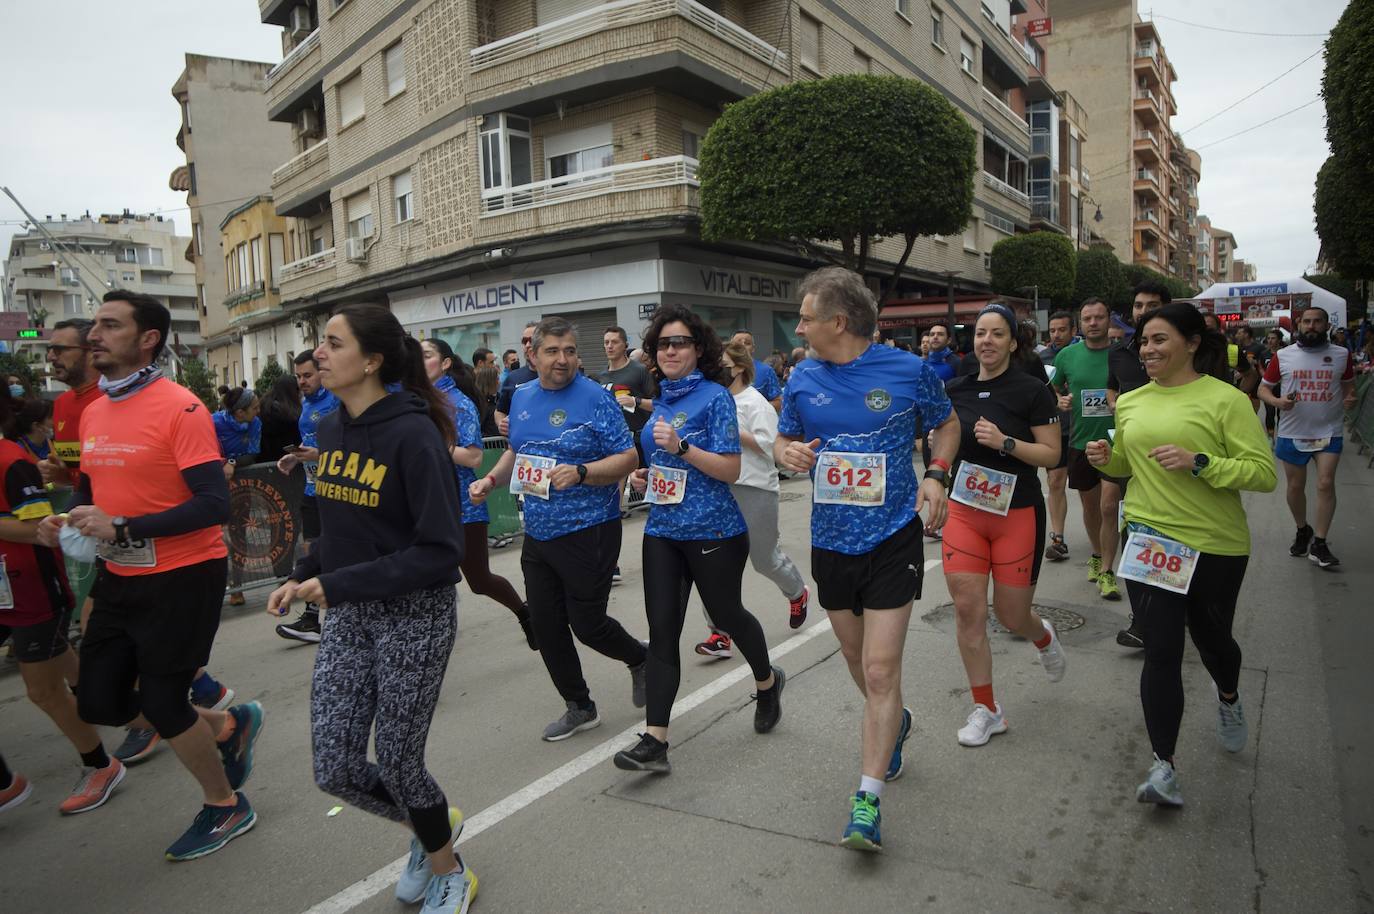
left=697, top=76, right=978, bottom=298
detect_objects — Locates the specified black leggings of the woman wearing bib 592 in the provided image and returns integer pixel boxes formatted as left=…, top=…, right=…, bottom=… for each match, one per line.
left=644, top=533, right=772, bottom=727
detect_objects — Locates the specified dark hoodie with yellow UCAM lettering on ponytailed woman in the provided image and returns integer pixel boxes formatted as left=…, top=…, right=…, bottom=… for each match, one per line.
left=291, top=390, right=463, bottom=606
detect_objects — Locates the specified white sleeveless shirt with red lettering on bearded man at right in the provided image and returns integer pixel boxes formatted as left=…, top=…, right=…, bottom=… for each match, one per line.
left=1264, top=344, right=1355, bottom=438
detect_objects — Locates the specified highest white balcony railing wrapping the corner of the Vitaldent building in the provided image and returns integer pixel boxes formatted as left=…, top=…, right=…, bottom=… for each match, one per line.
left=471, top=0, right=787, bottom=70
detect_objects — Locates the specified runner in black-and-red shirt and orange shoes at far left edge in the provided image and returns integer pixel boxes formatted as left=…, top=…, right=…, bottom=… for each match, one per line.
left=0, top=389, right=125, bottom=815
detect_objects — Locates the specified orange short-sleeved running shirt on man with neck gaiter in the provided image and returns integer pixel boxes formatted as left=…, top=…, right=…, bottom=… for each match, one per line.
left=81, top=378, right=228, bottom=575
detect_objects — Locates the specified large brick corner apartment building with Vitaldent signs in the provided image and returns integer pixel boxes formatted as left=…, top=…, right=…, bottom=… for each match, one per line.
left=250, top=0, right=1049, bottom=357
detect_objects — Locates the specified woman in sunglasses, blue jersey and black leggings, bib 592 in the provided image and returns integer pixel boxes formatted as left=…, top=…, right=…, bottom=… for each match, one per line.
left=614, top=305, right=787, bottom=774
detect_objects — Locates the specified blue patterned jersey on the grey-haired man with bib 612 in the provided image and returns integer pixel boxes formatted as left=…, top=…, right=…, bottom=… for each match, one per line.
left=778, top=345, right=951, bottom=555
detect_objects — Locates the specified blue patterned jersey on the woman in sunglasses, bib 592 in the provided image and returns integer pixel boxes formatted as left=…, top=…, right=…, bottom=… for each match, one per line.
left=639, top=371, right=745, bottom=540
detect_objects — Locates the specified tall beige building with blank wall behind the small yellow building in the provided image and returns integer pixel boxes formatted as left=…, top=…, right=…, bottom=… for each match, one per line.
left=169, top=54, right=294, bottom=382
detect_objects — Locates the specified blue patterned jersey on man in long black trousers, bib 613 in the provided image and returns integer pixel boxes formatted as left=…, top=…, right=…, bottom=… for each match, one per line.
left=510, top=375, right=635, bottom=540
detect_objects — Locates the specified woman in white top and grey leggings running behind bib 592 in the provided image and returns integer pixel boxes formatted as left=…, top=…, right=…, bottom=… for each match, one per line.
left=697, top=335, right=811, bottom=657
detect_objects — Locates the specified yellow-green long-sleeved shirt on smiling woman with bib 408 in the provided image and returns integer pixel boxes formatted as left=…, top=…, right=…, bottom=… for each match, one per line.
left=1101, top=377, right=1278, bottom=555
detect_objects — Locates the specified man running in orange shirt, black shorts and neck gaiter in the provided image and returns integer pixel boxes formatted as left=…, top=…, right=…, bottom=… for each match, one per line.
left=38, top=289, right=262, bottom=860
